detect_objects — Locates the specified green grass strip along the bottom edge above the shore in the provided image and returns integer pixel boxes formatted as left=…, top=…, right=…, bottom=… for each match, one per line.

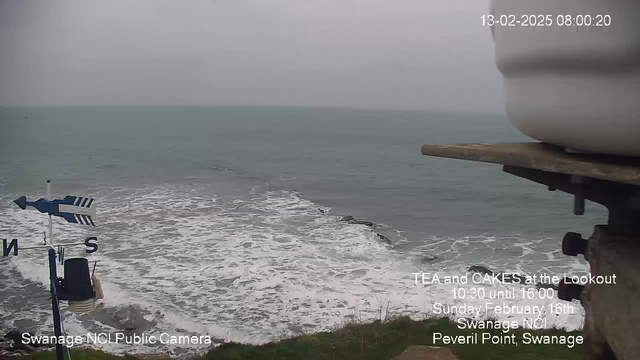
left=16, top=317, right=583, bottom=360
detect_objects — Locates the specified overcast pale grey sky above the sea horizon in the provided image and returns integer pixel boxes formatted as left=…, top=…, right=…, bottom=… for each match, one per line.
left=0, top=0, right=503, bottom=112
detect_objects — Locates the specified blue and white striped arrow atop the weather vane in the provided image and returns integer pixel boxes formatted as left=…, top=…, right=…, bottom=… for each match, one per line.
left=13, top=195, right=96, bottom=226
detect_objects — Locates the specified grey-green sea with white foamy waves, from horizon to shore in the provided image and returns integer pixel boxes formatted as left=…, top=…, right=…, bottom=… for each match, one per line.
left=0, top=107, right=606, bottom=354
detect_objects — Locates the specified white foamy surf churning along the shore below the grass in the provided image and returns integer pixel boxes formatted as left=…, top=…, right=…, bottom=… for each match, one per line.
left=0, top=186, right=583, bottom=351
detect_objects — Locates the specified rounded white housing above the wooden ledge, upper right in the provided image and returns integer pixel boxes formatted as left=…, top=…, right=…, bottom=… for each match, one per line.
left=491, top=0, right=640, bottom=156
